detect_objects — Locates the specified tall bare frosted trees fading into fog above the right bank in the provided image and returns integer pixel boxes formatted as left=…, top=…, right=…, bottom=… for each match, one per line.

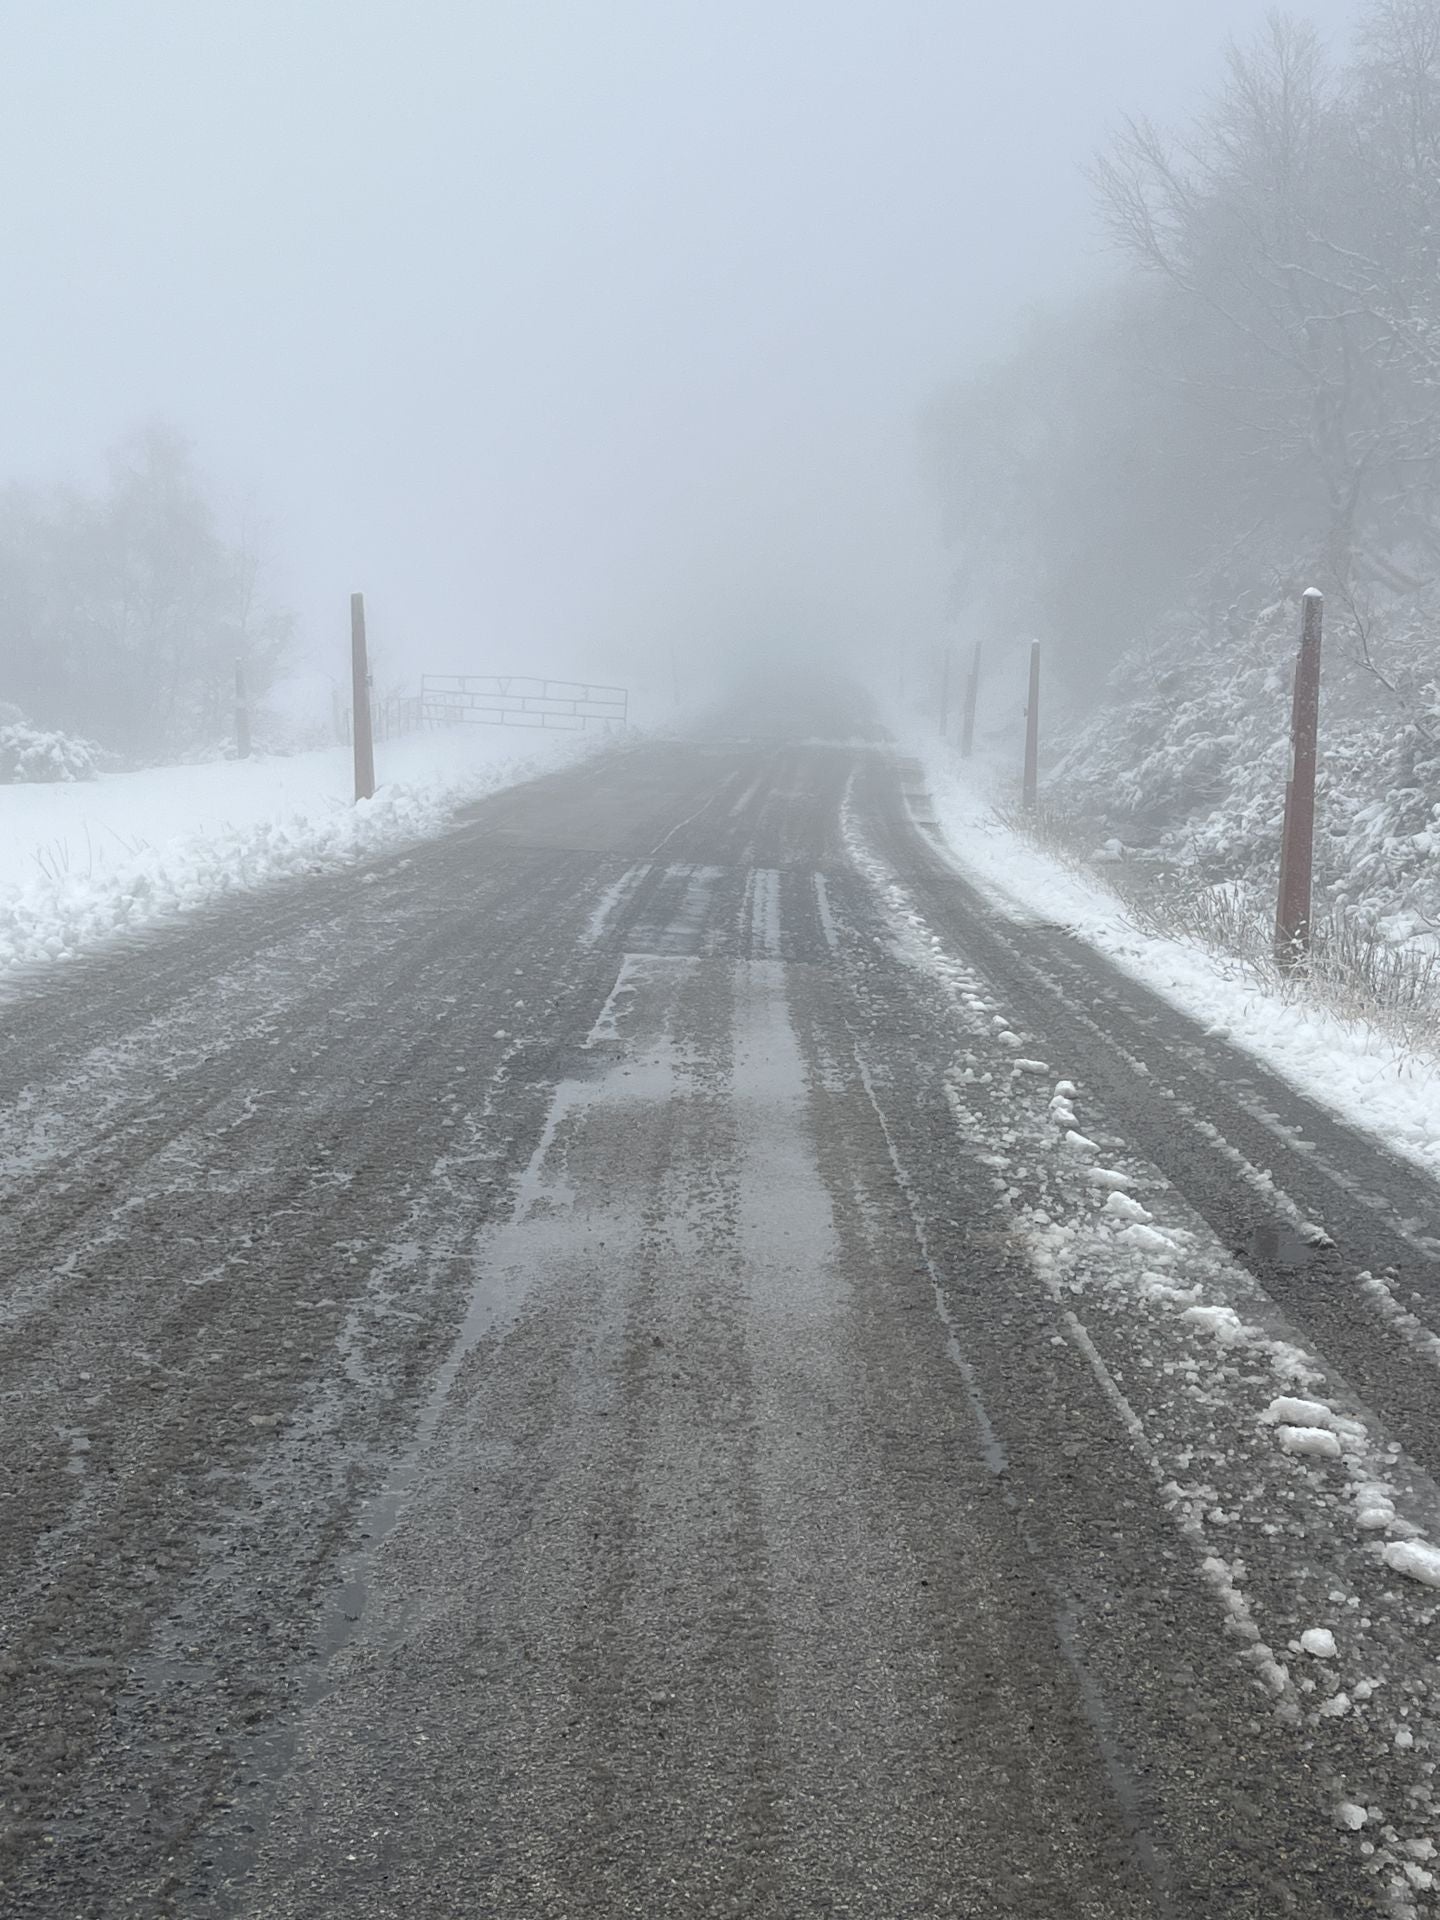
left=931, top=0, right=1440, bottom=698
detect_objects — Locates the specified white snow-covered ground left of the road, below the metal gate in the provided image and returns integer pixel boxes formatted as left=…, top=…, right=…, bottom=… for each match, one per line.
left=0, top=726, right=607, bottom=973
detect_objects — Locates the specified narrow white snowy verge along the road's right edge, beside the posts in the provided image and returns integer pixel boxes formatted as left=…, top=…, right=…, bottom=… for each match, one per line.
left=895, top=720, right=1440, bottom=1173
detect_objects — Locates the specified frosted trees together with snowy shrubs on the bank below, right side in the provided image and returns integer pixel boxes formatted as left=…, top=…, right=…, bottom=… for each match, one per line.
left=931, top=0, right=1440, bottom=939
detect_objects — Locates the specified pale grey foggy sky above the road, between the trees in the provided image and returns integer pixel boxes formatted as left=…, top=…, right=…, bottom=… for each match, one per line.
left=0, top=0, right=1350, bottom=698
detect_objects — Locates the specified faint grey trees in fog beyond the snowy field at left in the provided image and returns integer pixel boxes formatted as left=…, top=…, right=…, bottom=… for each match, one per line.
left=0, top=428, right=290, bottom=764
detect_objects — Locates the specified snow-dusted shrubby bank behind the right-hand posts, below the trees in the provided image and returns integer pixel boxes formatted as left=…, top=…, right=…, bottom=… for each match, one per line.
left=1046, top=601, right=1440, bottom=941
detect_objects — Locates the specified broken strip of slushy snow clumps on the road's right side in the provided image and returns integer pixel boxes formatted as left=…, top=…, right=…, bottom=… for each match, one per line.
left=843, top=804, right=1440, bottom=1920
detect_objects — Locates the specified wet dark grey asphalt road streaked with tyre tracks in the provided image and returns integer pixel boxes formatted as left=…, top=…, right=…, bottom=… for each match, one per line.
left=0, top=698, right=1440, bottom=1920
